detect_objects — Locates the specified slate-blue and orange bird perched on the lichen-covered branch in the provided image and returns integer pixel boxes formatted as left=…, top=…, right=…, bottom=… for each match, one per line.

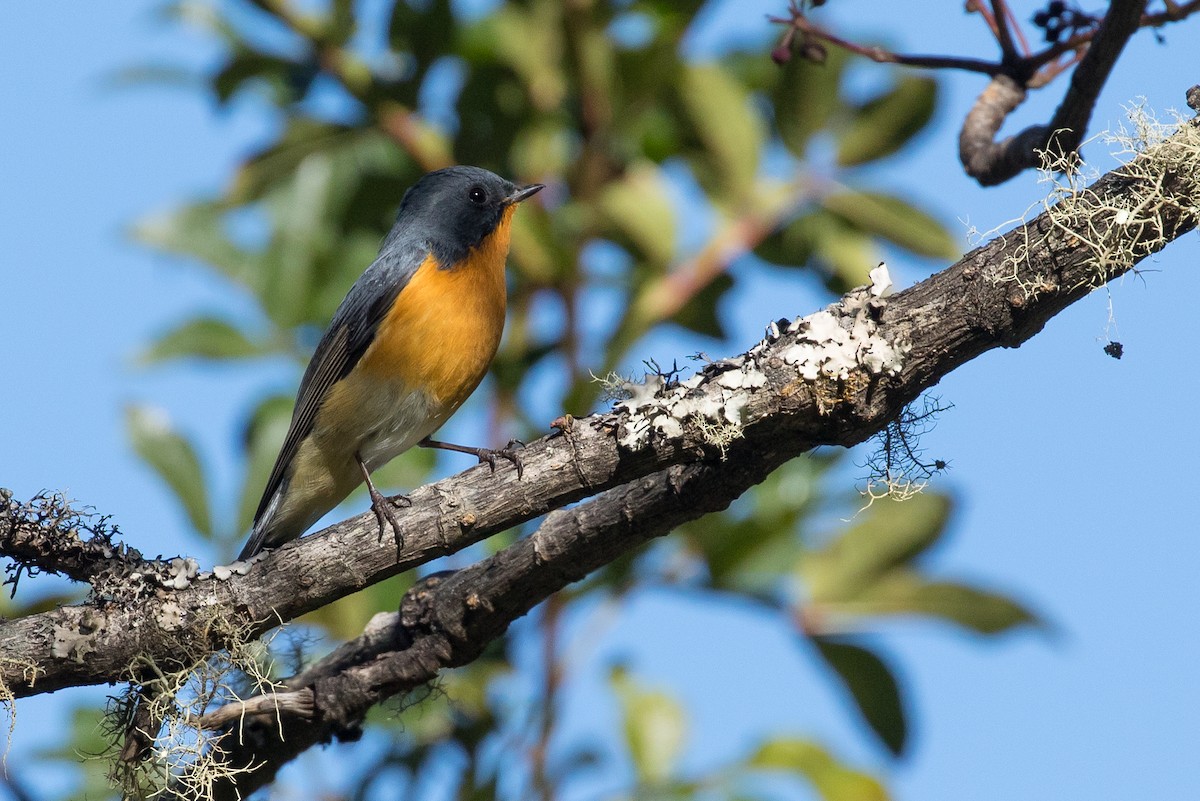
left=238, top=167, right=545, bottom=561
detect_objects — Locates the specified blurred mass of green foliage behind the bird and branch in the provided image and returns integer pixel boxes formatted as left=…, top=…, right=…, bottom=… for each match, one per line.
left=14, top=2, right=1185, bottom=799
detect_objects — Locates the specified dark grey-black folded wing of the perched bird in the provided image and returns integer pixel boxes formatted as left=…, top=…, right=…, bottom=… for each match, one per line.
left=254, top=247, right=428, bottom=537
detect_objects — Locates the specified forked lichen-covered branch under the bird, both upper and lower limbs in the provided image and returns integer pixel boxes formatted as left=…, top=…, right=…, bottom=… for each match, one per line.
left=0, top=92, right=1200, bottom=789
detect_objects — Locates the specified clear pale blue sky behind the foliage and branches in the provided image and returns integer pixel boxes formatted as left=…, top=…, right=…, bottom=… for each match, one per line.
left=0, top=0, right=1200, bottom=801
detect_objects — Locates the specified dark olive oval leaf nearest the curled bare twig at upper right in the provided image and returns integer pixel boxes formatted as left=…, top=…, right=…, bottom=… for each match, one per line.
left=838, top=76, right=937, bottom=167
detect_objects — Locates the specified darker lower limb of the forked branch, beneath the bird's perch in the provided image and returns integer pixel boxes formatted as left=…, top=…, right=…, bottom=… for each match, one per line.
left=193, top=453, right=791, bottom=799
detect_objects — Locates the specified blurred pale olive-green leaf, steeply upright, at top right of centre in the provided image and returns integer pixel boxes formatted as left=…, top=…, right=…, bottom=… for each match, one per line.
left=678, top=64, right=766, bottom=203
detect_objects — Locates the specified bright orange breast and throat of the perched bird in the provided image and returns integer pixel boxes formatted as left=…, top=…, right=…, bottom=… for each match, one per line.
left=350, top=206, right=515, bottom=412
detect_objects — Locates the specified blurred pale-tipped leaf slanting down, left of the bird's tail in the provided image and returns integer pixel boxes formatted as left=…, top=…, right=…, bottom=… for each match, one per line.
left=125, top=406, right=212, bottom=537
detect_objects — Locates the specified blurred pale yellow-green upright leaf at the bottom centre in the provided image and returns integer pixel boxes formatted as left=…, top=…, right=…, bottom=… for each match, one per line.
left=612, top=670, right=685, bottom=784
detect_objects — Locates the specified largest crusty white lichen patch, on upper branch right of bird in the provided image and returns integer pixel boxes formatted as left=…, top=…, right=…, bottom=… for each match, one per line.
left=614, top=263, right=911, bottom=448
